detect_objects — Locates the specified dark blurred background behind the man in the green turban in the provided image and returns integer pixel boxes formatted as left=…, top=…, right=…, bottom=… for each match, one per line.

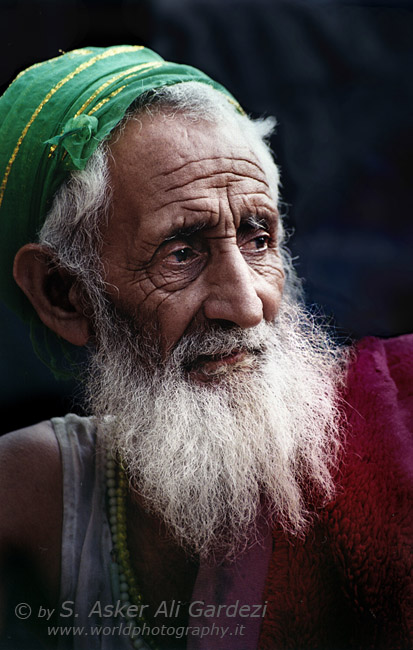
left=0, top=0, right=413, bottom=431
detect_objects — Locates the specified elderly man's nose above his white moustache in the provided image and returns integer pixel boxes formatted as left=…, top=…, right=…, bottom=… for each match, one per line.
left=203, top=246, right=263, bottom=328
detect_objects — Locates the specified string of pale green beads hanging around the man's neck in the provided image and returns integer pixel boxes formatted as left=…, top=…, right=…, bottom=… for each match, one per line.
left=106, top=454, right=157, bottom=650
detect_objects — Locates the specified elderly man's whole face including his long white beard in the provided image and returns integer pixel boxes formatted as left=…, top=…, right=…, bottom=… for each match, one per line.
left=87, top=116, right=341, bottom=558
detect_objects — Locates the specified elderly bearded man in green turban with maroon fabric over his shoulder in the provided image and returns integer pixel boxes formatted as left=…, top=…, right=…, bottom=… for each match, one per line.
left=0, top=46, right=413, bottom=650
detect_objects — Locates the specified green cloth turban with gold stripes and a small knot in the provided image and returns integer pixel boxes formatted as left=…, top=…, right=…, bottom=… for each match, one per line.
left=0, top=45, right=238, bottom=321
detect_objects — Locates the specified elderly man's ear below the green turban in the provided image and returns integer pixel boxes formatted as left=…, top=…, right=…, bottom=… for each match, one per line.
left=13, top=244, right=92, bottom=345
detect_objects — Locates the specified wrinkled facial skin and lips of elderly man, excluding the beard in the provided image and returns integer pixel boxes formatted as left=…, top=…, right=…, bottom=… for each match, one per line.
left=103, top=116, right=284, bottom=372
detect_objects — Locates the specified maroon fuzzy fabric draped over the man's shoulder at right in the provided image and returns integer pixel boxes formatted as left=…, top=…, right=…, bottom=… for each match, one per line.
left=259, top=335, right=413, bottom=650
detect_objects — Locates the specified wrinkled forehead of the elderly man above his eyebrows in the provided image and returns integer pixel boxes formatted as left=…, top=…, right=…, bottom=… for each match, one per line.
left=110, top=114, right=268, bottom=199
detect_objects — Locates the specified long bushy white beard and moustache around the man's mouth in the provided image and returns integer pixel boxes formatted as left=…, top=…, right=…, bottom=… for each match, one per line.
left=88, top=299, right=346, bottom=559
